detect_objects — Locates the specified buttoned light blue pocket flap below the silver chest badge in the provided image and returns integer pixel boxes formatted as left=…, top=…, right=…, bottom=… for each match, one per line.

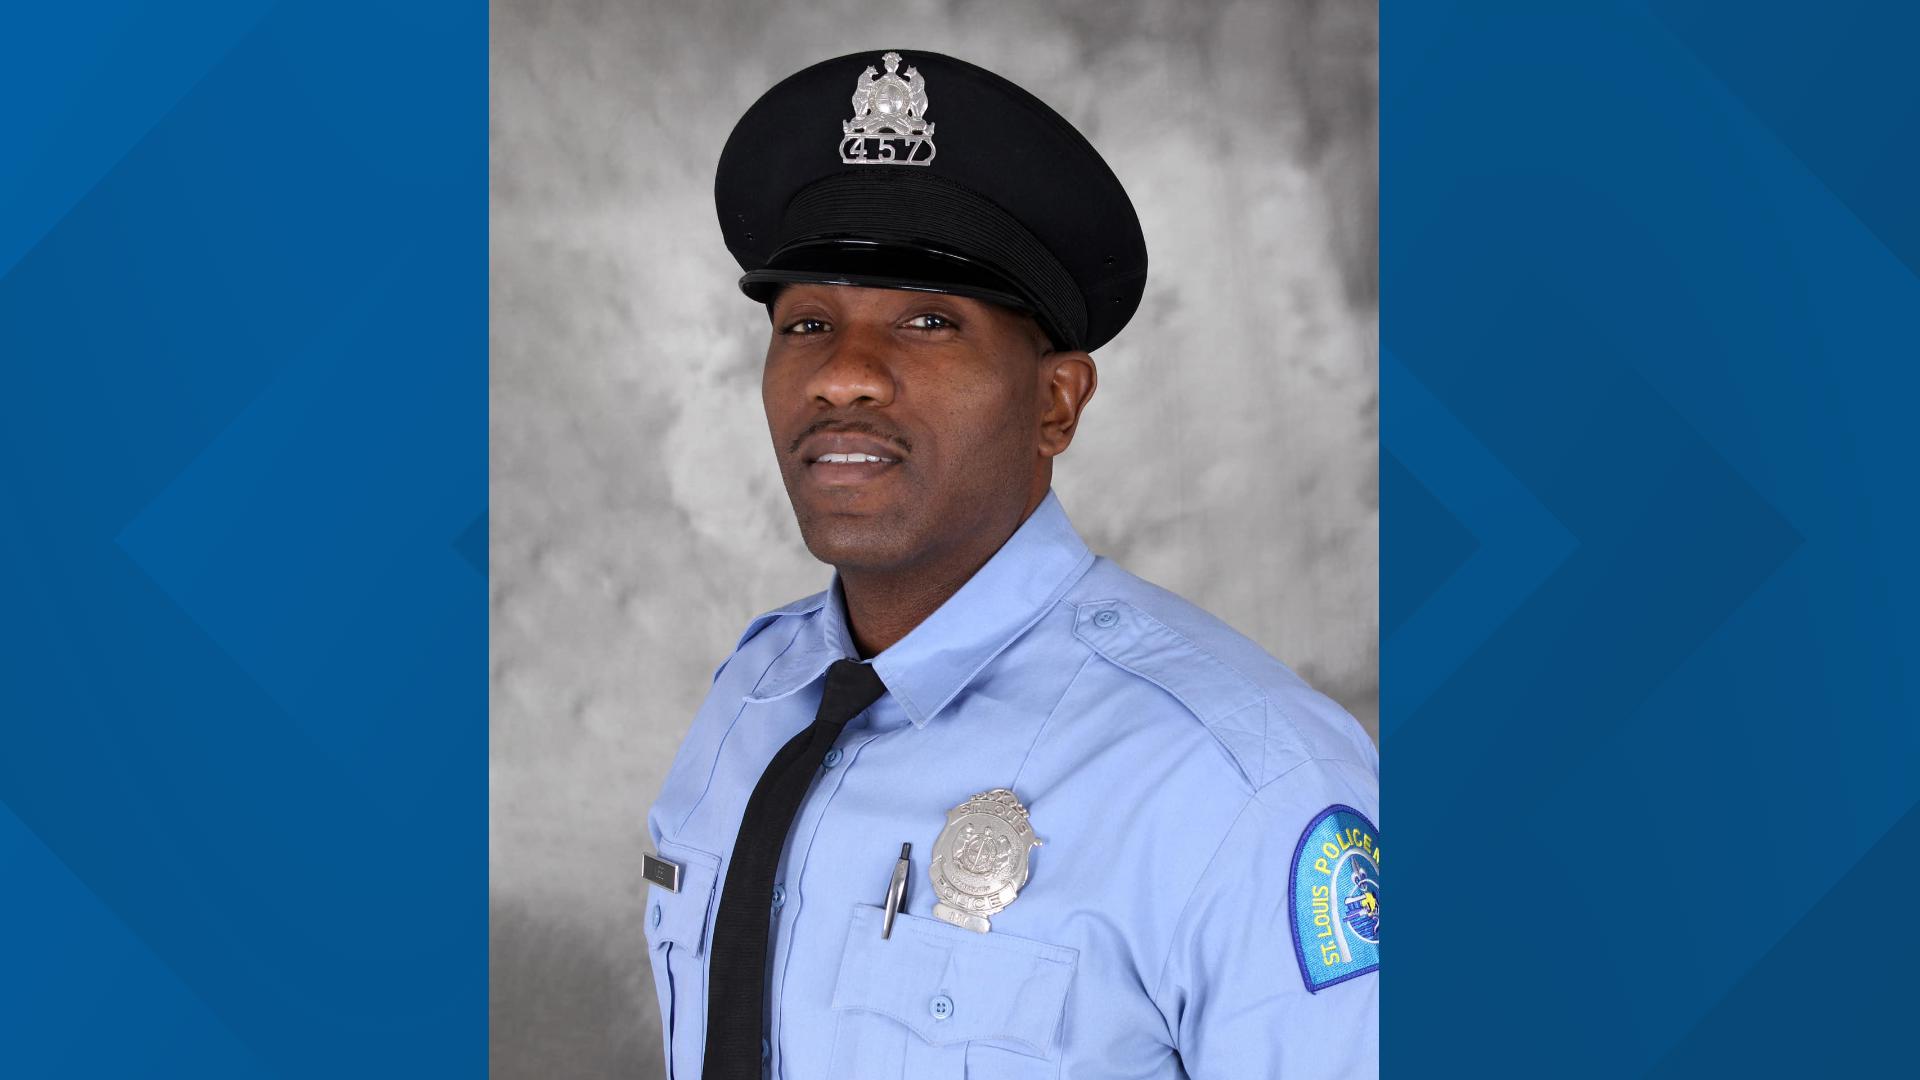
left=833, top=903, right=1079, bottom=1059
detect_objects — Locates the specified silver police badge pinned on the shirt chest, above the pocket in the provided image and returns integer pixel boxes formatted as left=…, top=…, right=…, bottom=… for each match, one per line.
left=927, top=788, right=1041, bottom=934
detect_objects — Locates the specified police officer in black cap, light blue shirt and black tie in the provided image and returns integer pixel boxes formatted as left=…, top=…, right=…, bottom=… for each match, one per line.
left=645, top=50, right=1380, bottom=1080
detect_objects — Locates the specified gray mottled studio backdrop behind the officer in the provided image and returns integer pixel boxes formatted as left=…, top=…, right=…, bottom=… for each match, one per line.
left=492, top=0, right=1379, bottom=1078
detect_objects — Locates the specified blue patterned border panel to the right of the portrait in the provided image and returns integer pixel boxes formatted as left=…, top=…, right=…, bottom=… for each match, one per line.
left=1380, top=0, right=1920, bottom=1076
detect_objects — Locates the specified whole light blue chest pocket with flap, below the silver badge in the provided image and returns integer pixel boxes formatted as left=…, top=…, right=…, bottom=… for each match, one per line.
left=828, top=905, right=1079, bottom=1080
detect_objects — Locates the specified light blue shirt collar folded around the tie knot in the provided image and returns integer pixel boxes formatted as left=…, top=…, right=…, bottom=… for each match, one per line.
left=749, top=492, right=1092, bottom=726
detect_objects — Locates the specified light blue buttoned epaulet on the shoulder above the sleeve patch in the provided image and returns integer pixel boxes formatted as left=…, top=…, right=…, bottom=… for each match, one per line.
left=1068, top=559, right=1371, bottom=790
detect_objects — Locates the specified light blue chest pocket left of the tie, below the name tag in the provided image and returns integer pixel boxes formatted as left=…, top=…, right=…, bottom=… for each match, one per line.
left=647, top=842, right=720, bottom=1080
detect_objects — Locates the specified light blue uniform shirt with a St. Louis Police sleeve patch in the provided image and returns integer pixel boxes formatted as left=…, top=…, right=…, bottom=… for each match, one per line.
left=645, top=494, right=1379, bottom=1080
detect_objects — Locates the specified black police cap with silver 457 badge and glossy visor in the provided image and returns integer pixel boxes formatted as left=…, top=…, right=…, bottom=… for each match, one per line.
left=714, top=52, right=1146, bottom=350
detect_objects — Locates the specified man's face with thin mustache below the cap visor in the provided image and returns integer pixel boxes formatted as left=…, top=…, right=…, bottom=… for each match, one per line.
left=760, top=284, right=1091, bottom=573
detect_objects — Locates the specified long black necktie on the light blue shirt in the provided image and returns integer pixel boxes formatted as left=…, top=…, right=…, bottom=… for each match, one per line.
left=701, top=659, right=887, bottom=1080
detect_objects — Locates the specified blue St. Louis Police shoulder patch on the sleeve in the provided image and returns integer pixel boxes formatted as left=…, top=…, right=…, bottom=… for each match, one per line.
left=1286, top=805, right=1380, bottom=994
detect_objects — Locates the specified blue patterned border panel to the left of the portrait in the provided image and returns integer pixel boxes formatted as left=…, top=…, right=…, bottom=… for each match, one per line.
left=0, top=0, right=488, bottom=1078
